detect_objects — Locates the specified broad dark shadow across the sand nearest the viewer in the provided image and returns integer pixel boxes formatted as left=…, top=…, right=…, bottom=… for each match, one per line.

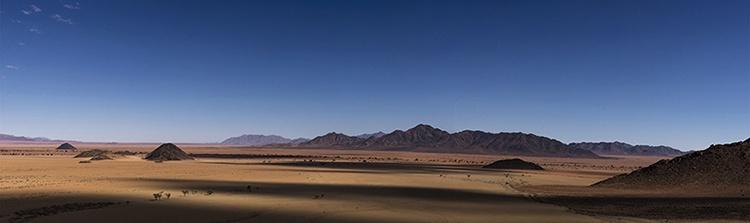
left=0, top=178, right=750, bottom=222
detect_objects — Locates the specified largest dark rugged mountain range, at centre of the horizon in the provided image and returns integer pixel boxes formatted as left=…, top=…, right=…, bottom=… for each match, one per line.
left=299, top=124, right=600, bottom=158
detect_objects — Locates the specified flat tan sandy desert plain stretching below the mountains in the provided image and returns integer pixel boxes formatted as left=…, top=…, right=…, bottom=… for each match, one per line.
left=0, top=144, right=750, bottom=222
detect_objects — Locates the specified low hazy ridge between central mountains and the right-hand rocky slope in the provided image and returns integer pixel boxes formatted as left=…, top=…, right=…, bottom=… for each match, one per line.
left=569, top=142, right=687, bottom=156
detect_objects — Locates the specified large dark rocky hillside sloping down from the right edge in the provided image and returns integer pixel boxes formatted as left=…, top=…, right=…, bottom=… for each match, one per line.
left=592, top=139, right=750, bottom=193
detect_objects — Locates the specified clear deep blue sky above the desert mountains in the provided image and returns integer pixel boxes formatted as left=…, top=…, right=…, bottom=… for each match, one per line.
left=0, top=0, right=750, bottom=150
